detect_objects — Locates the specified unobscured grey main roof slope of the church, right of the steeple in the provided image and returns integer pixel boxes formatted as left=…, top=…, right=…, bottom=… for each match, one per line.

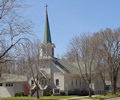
left=54, top=59, right=80, bottom=74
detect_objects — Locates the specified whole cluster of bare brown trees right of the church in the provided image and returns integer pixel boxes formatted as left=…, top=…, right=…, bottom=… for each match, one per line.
left=65, top=28, right=120, bottom=96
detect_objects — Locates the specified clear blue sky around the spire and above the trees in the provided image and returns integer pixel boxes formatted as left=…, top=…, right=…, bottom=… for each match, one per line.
left=24, top=0, right=120, bottom=55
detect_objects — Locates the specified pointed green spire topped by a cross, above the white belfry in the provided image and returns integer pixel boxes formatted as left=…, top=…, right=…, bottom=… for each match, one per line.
left=43, top=4, right=52, bottom=44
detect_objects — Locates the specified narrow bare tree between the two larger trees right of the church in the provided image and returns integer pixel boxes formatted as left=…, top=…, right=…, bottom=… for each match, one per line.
left=91, top=32, right=108, bottom=95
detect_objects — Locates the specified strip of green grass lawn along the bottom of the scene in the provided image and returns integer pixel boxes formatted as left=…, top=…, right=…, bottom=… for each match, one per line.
left=0, top=92, right=120, bottom=100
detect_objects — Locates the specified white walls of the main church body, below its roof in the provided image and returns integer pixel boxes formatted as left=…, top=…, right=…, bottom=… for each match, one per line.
left=29, top=60, right=103, bottom=91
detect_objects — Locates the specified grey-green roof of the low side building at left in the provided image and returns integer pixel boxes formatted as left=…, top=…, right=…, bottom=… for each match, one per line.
left=0, top=73, right=27, bottom=82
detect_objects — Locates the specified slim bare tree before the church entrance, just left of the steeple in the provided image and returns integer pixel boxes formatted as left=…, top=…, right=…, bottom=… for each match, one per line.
left=17, top=40, right=41, bottom=98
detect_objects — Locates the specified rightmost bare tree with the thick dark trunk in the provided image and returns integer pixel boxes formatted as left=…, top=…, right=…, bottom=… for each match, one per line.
left=96, top=28, right=120, bottom=94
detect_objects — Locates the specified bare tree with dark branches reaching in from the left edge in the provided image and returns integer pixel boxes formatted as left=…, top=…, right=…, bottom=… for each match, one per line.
left=0, top=0, right=32, bottom=75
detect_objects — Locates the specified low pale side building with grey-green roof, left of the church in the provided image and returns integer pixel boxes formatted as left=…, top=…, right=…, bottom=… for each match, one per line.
left=0, top=73, right=27, bottom=98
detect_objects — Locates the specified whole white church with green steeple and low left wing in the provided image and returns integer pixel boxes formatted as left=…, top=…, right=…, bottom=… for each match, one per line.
left=0, top=6, right=103, bottom=97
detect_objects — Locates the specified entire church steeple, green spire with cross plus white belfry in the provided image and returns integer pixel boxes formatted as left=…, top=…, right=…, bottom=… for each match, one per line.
left=40, top=4, right=55, bottom=59
